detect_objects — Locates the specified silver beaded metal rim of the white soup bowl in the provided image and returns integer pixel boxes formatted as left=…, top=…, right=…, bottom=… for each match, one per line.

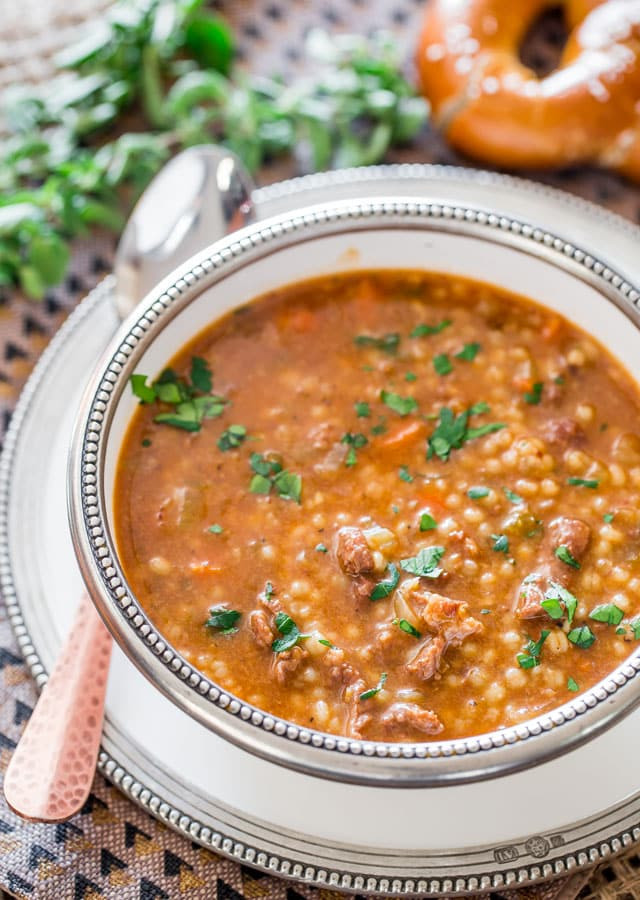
left=66, top=198, right=640, bottom=785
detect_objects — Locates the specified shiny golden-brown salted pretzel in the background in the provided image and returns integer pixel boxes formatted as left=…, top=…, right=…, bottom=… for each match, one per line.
left=417, top=0, right=640, bottom=181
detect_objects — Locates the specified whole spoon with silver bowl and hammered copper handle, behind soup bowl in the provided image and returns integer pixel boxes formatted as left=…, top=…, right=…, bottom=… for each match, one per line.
left=4, top=145, right=254, bottom=822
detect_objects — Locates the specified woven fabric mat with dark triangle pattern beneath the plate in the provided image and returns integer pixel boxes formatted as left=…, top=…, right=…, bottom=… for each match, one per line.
left=0, top=0, right=640, bottom=900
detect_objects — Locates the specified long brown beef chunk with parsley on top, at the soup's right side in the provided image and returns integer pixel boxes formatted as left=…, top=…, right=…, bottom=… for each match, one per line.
left=515, top=516, right=591, bottom=619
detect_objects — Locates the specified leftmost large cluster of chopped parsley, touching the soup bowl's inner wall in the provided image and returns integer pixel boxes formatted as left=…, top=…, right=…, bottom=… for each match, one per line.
left=129, top=356, right=228, bottom=432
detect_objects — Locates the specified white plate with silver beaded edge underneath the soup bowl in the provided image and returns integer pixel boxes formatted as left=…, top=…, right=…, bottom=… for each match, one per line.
left=5, top=166, right=640, bottom=895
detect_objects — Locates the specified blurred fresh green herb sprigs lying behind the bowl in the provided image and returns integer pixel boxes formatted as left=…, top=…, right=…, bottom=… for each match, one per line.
left=0, top=0, right=427, bottom=299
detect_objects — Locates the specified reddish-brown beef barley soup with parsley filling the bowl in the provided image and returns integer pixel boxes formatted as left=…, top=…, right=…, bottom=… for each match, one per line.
left=115, top=271, right=640, bottom=741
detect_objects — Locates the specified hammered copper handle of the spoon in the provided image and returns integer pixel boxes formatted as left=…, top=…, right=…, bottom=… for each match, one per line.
left=4, top=593, right=112, bottom=822
